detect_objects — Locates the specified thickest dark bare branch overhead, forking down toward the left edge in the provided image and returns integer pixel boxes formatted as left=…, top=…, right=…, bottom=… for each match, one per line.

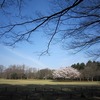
left=0, top=0, right=83, bottom=47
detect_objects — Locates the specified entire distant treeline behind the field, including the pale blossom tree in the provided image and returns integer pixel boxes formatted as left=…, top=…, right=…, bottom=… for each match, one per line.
left=0, top=61, right=100, bottom=81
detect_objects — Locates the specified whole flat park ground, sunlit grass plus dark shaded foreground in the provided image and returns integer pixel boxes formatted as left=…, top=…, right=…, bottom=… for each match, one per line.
left=0, top=79, right=100, bottom=100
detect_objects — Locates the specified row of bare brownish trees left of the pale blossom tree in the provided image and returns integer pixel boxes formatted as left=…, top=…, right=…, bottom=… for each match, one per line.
left=0, top=65, right=52, bottom=79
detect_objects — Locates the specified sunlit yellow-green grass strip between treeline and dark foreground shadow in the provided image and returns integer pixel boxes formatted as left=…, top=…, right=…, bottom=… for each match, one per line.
left=0, top=79, right=100, bottom=85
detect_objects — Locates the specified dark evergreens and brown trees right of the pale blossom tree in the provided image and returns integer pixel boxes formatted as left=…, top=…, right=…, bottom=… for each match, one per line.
left=71, top=61, right=100, bottom=81
